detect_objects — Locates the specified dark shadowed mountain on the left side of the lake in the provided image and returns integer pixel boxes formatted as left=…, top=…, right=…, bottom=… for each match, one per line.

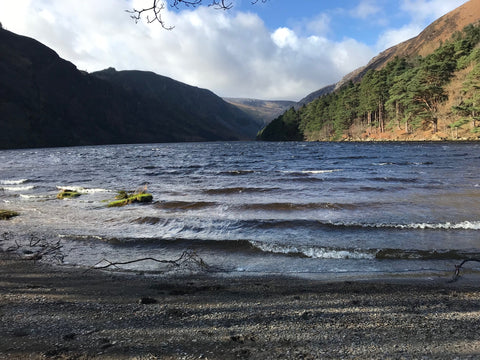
left=0, top=28, right=260, bottom=148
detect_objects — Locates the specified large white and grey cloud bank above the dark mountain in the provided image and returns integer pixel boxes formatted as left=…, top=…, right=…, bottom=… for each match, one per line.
left=0, top=0, right=374, bottom=100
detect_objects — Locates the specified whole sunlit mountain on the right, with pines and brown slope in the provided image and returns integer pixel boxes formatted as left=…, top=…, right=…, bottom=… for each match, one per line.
left=258, top=0, right=480, bottom=141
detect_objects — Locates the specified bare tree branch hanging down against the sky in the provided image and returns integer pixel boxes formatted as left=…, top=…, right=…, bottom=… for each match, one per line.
left=125, top=0, right=268, bottom=30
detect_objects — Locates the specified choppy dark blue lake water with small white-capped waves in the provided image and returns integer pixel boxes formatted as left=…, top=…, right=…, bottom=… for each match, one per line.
left=0, top=142, right=480, bottom=277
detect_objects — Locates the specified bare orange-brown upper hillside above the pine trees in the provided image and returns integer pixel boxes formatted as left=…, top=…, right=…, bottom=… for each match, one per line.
left=335, top=0, right=480, bottom=89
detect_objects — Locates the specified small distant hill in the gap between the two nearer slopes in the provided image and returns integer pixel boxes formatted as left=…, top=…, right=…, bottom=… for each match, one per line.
left=223, top=98, right=296, bottom=127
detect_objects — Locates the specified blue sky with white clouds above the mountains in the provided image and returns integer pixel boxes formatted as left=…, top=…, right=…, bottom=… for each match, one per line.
left=0, top=0, right=467, bottom=101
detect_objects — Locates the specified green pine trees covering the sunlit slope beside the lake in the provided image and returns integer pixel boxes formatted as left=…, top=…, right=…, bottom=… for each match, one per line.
left=258, top=25, right=480, bottom=141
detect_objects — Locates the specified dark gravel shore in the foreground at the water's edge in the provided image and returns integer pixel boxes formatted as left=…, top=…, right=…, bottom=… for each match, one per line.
left=0, top=259, right=480, bottom=360
